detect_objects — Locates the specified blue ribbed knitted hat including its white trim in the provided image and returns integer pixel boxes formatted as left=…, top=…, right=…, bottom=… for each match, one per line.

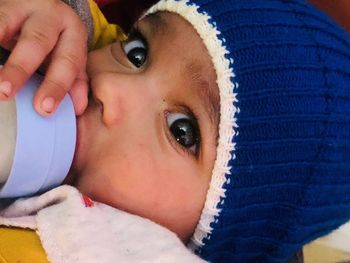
left=148, top=0, right=350, bottom=263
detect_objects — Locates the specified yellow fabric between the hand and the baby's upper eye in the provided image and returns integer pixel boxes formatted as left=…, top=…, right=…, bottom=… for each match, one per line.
left=89, top=0, right=126, bottom=49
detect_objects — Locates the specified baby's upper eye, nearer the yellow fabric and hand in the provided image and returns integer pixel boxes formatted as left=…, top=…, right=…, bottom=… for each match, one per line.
left=122, top=32, right=148, bottom=68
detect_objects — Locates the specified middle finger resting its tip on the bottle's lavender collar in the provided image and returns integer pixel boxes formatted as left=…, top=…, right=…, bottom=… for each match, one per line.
left=34, top=21, right=87, bottom=116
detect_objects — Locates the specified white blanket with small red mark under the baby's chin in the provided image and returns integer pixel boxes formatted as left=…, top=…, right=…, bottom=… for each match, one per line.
left=0, top=186, right=205, bottom=263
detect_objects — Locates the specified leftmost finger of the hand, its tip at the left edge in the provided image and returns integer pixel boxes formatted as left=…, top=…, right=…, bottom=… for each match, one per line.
left=0, top=16, right=60, bottom=99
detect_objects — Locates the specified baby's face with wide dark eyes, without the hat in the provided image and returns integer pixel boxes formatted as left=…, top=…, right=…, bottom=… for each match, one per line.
left=73, top=13, right=219, bottom=241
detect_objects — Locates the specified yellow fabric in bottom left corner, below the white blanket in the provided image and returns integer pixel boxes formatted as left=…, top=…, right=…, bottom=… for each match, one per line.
left=0, top=227, right=49, bottom=263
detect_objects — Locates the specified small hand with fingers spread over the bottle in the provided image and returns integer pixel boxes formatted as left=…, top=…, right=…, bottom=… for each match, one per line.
left=0, top=0, right=88, bottom=116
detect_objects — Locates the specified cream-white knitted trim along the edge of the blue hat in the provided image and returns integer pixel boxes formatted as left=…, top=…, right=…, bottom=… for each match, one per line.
left=146, top=0, right=239, bottom=250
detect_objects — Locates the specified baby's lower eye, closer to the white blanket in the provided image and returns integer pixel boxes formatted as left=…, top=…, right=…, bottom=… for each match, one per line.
left=166, top=112, right=200, bottom=154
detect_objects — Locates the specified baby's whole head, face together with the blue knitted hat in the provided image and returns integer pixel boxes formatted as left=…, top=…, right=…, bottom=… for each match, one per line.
left=0, top=0, right=350, bottom=262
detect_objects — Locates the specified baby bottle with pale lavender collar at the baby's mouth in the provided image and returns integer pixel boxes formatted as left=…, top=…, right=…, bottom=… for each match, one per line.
left=0, top=49, right=76, bottom=198
